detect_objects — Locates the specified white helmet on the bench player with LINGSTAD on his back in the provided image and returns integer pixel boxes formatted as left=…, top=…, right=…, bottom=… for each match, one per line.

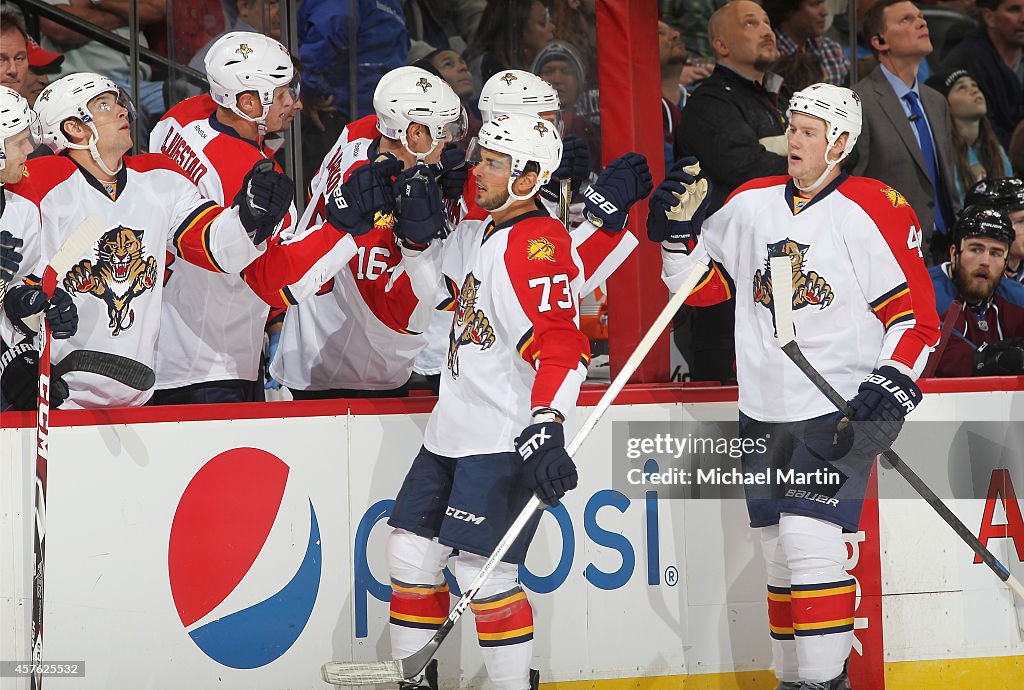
left=205, top=31, right=297, bottom=123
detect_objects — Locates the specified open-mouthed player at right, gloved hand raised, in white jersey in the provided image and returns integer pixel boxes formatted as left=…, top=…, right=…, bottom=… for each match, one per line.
left=648, top=84, right=938, bottom=690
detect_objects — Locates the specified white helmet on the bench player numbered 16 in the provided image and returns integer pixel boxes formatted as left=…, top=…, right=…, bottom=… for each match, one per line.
left=374, top=67, right=467, bottom=159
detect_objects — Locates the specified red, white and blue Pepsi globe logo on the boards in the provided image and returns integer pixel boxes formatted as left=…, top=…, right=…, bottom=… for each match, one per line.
left=167, top=448, right=323, bottom=669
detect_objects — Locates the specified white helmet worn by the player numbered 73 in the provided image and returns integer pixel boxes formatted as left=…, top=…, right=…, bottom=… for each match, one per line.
left=467, top=113, right=562, bottom=211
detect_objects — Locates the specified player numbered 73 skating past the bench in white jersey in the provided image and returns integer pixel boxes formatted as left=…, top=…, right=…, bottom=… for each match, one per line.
left=388, top=115, right=590, bottom=690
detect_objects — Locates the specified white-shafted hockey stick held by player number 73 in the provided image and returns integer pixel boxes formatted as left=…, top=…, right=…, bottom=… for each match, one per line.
left=321, top=249, right=711, bottom=685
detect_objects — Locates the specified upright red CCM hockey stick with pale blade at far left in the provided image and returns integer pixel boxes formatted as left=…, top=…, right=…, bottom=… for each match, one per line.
left=31, top=215, right=105, bottom=690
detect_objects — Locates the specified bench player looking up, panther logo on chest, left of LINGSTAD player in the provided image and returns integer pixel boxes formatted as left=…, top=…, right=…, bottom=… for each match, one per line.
left=28, top=73, right=292, bottom=407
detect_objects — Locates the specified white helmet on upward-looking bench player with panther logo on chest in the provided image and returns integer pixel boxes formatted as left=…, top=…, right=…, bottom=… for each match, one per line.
left=35, top=72, right=135, bottom=175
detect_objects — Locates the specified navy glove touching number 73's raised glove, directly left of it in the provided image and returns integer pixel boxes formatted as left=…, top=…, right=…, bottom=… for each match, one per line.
left=327, top=155, right=401, bottom=236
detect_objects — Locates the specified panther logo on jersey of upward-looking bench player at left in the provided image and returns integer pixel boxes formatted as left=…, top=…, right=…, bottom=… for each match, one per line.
left=63, top=225, right=158, bottom=336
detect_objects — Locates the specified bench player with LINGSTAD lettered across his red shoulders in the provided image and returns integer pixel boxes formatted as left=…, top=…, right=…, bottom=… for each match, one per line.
left=150, top=32, right=344, bottom=404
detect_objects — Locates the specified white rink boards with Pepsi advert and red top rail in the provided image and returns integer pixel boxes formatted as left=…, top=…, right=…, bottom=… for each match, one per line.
left=0, top=380, right=1024, bottom=690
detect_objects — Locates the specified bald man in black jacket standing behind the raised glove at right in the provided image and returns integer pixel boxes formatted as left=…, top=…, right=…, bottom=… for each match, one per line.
left=675, top=0, right=787, bottom=381
